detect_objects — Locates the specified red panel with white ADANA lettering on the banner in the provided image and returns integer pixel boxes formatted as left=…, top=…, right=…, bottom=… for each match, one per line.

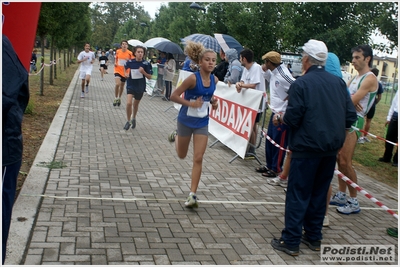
left=210, top=95, right=257, bottom=140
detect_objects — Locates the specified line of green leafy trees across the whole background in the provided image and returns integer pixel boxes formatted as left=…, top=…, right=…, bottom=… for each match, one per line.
left=37, top=2, right=398, bottom=93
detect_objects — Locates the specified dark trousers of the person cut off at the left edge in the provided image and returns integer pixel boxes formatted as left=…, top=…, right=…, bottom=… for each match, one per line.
left=1, top=161, right=21, bottom=264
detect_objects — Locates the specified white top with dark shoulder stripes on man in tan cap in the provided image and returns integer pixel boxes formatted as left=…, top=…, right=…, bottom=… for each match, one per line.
left=264, top=63, right=295, bottom=113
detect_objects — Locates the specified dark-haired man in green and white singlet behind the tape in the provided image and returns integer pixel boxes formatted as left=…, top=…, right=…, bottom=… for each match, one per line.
left=330, top=45, right=378, bottom=214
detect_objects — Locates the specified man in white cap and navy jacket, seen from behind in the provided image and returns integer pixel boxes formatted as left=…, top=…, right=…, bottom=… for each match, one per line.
left=271, top=40, right=357, bottom=256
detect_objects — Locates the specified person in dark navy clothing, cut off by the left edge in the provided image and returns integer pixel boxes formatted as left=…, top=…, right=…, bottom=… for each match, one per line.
left=2, top=35, right=29, bottom=264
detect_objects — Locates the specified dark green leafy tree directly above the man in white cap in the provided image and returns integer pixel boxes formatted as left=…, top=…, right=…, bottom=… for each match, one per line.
left=282, top=2, right=372, bottom=63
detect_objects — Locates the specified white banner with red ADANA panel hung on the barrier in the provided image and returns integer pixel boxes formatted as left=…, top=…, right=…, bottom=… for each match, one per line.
left=174, top=70, right=265, bottom=158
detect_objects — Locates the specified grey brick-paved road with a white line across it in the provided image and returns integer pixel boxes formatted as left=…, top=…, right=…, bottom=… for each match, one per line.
left=6, top=63, right=398, bottom=265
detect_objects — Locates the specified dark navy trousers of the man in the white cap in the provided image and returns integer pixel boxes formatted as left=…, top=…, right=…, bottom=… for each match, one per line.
left=282, top=156, right=336, bottom=247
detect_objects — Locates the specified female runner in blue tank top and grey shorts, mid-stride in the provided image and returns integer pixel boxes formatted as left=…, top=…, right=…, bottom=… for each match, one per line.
left=168, top=42, right=218, bottom=208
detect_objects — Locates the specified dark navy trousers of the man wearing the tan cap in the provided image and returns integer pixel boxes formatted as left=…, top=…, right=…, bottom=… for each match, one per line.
left=265, top=113, right=289, bottom=173
